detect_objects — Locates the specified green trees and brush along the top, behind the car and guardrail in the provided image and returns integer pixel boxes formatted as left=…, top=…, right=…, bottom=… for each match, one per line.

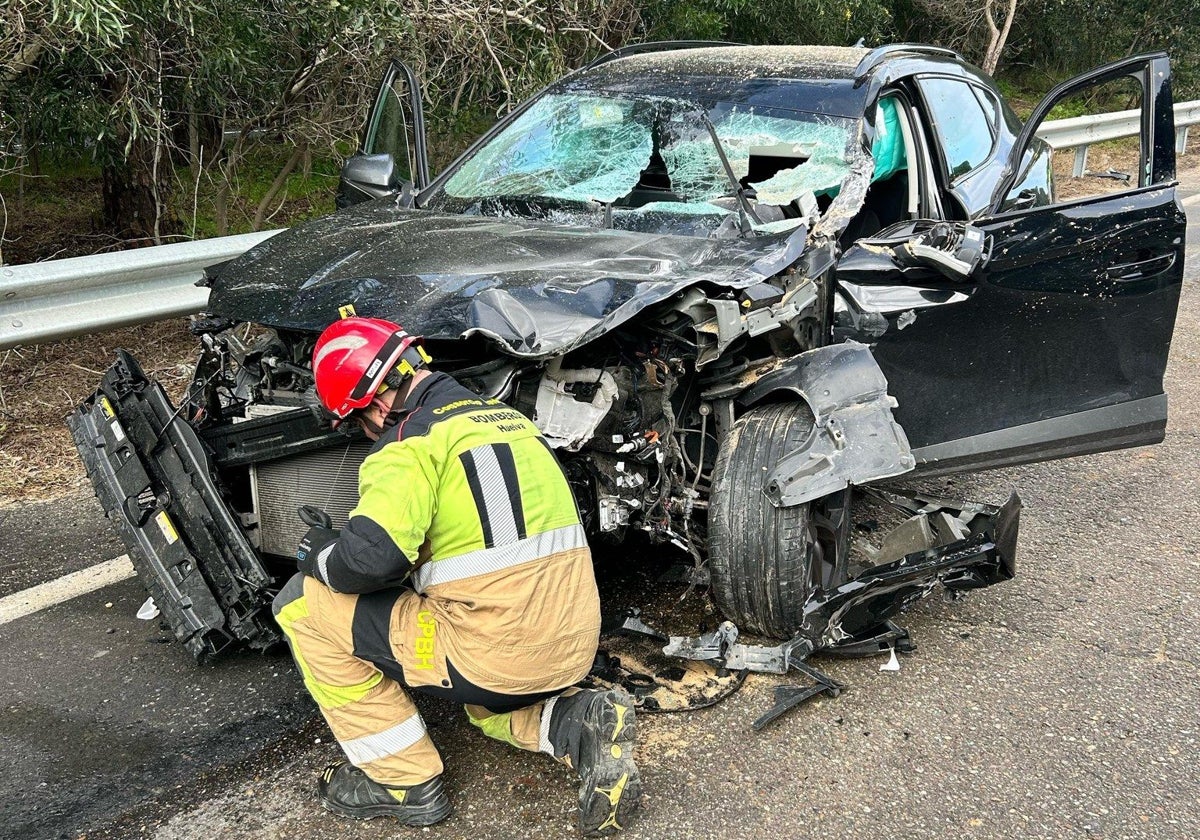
left=0, top=0, right=1200, bottom=259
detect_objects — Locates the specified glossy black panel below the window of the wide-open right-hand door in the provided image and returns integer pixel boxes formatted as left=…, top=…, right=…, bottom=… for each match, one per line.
left=892, top=188, right=1184, bottom=458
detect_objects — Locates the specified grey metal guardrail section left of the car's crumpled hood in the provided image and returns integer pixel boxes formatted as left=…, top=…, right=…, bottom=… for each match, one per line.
left=0, top=230, right=280, bottom=350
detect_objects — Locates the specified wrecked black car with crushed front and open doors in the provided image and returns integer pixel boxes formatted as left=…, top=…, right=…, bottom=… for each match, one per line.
left=68, top=43, right=1184, bottom=670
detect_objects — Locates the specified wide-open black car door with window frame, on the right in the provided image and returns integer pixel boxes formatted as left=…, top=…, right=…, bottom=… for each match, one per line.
left=839, top=54, right=1186, bottom=474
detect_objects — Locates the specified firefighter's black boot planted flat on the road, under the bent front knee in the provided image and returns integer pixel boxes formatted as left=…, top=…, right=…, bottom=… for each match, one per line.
left=317, top=761, right=454, bottom=826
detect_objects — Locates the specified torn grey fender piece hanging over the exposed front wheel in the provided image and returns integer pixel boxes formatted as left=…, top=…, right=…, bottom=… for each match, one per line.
left=738, top=341, right=916, bottom=508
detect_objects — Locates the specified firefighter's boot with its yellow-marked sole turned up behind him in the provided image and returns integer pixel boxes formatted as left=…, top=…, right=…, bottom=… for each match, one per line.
left=547, top=691, right=642, bottom=834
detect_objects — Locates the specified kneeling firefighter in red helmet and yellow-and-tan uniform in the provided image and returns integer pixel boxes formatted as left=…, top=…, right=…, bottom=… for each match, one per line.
left=275, top=317, right=641, bottom=833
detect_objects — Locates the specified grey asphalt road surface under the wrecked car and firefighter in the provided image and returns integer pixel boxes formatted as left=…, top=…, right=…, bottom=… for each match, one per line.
left=0, top=173, right=1200, bottom=840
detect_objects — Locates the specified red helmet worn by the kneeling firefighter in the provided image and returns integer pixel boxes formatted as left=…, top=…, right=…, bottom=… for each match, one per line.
left=312, top=317, right=430, bottom=426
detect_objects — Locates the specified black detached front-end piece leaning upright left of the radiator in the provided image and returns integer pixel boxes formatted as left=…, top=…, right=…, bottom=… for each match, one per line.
left=67, top=350, right=281, bottom=661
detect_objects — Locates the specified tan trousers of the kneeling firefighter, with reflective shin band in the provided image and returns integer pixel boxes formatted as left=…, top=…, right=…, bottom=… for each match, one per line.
left=274, top=575, right=595, bottom=786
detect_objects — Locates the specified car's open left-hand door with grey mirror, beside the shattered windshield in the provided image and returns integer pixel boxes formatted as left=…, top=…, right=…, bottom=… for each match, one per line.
left=337, top=61, right=430, bottom=208
